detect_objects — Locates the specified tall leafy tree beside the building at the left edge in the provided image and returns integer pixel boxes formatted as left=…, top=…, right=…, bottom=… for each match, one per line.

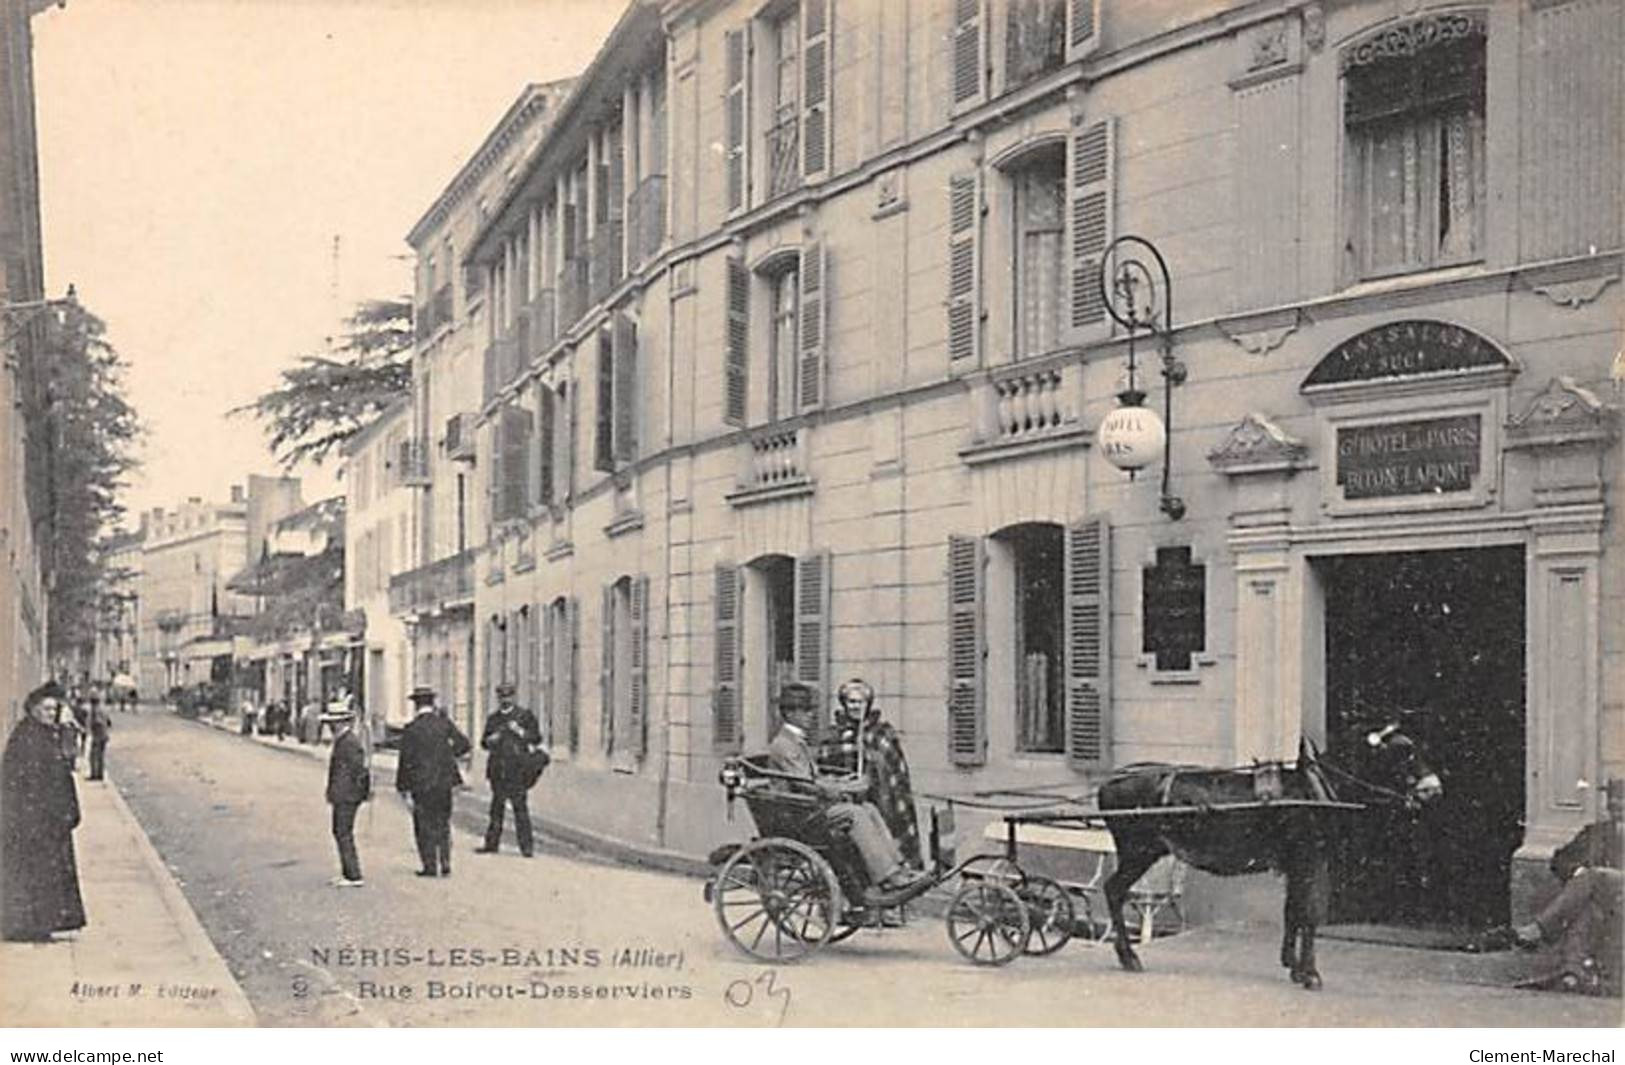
left=34, top=304, right=143, bottom=657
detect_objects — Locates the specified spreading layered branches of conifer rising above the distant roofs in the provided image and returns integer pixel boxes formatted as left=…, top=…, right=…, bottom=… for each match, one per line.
left=231, top=298, right=413, bottom=470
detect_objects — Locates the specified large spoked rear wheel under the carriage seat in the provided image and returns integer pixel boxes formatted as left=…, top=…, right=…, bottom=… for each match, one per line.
left=712, top=839, right=840, bottom=963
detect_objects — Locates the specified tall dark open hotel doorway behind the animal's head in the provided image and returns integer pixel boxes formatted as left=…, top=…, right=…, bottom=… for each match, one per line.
left=1316, top=546, right=1524, bottom=933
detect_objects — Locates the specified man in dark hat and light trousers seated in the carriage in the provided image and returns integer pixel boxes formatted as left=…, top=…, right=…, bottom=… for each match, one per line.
left=767, top=685, right=926, bottom=893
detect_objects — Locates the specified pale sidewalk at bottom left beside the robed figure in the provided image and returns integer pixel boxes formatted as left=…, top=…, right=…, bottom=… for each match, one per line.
left=0, top=776, right=255, bottom=1028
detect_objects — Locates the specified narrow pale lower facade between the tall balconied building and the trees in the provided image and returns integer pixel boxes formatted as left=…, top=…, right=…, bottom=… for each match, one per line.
left=345, top=400, right=427, bottom=740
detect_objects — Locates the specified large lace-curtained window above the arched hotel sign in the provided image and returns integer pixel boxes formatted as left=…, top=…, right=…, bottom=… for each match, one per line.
left=1342, top=13, right=1485, bottom=281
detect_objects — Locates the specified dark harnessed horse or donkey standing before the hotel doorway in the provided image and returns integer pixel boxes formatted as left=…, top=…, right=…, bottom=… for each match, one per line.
left=1097, top=725, right=1445, bottom=990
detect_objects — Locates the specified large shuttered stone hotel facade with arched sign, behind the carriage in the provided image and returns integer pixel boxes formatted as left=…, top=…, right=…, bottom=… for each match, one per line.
left=462, top=0, right=1625, bottom=927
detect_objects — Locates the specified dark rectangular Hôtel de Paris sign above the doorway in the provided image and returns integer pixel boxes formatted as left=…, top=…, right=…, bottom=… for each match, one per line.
left=1337, top=415, right=1480, bottom=499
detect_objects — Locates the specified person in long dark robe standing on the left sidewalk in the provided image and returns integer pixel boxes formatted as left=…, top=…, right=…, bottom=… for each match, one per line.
left=0, top=683, right=85, bottom=941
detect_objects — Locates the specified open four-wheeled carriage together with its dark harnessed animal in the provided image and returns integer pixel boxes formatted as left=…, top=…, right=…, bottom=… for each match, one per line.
left=705, top=727, right=1440, bottom=990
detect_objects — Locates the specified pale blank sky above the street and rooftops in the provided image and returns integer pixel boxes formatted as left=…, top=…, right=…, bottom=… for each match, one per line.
left=34, top=0, right=624, bottom=524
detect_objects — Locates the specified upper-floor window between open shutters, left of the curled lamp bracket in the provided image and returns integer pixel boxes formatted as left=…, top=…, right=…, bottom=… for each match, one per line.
left=1011, top=145, right=1066, bottom=356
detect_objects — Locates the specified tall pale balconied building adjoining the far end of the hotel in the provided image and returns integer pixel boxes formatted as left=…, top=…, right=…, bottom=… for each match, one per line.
left=388, top=83, right=567, bottom=744
